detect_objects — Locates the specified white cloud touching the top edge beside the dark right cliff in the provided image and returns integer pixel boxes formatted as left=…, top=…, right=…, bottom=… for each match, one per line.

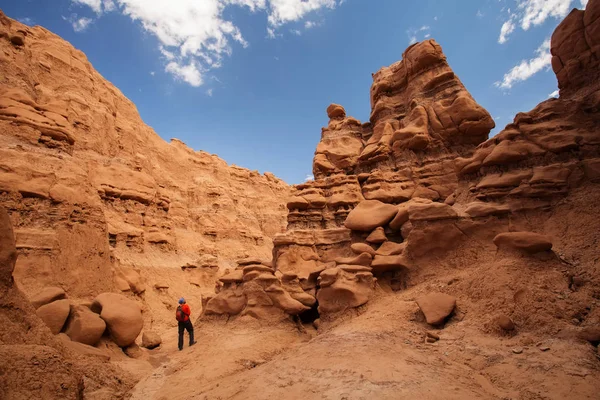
left=498, top=0, right=587, bottom=43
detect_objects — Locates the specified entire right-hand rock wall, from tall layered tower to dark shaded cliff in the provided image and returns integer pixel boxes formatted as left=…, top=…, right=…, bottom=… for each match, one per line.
left=228, top=1, right=600, bottom=324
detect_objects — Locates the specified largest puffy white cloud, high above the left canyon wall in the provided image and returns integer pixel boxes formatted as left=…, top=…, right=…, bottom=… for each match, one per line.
left=71, top=0, right=343, bottom=86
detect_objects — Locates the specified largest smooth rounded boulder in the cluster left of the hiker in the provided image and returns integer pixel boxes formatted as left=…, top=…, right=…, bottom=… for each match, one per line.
left=91, top=293, right=144, bottom=347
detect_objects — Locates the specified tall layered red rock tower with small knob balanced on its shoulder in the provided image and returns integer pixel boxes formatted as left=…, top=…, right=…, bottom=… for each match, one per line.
left=274, top=40, right=494, bottom=313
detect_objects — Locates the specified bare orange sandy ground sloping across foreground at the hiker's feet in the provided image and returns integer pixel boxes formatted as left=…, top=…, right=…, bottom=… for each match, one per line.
left=126, top=284, right=600, bottom=400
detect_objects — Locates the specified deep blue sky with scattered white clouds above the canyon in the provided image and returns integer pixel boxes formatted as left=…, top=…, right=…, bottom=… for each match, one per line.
left=0, top=0, right=587, bottom=183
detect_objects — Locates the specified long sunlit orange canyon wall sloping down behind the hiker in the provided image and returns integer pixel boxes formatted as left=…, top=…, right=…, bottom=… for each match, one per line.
left=0, top=13, right=289, bottom=328
